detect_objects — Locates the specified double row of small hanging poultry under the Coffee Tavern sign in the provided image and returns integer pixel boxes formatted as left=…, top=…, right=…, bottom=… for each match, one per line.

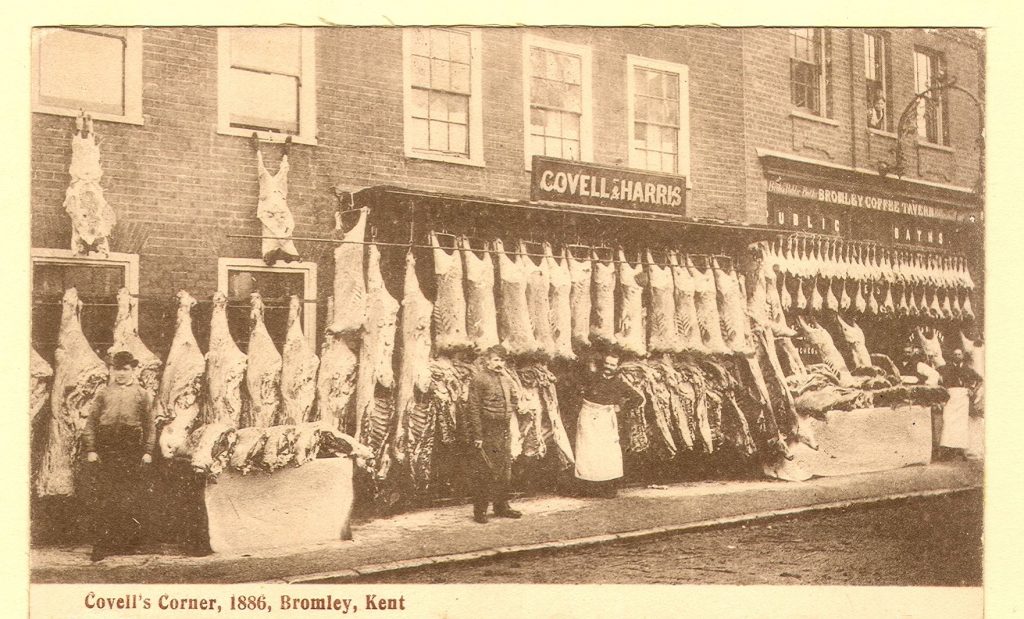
left=759, top=237, right=975, bottom=321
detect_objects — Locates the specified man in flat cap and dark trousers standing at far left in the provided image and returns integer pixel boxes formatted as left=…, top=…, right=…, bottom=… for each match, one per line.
left=82, top=350, right=157, bottom=561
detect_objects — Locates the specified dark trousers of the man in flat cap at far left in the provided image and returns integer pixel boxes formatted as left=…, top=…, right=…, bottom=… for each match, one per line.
left=86, top=425, right=152, bottom=554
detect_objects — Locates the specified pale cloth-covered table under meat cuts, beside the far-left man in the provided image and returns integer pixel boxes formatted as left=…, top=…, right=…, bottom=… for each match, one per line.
left=206, top=457, right=352, bottom=552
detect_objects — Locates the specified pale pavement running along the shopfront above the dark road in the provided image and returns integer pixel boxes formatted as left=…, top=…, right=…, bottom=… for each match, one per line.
left=31, top=461, right=984, bottom=583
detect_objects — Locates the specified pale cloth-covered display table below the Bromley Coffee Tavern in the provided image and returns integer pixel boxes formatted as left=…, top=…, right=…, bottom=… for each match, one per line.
left=791, top=406, right=932, bottom=477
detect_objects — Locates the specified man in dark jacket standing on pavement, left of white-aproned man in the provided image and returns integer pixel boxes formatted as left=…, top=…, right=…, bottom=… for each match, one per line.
left=466, top=345, right=522, bottom=524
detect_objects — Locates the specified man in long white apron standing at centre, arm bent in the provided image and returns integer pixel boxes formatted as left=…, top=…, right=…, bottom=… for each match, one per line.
left=575, top=354, right=643, bottom=498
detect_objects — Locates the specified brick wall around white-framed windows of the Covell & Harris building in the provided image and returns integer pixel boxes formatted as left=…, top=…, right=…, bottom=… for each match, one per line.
left=32, top=28, right=744, bottom=350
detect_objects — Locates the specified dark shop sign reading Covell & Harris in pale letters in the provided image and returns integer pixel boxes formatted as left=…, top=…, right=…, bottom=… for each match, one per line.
left=529, top=157, right=686, bottom=214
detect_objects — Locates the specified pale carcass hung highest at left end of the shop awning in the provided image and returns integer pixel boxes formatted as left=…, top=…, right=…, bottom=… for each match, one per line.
left=327, top=207, right=370, bottom=334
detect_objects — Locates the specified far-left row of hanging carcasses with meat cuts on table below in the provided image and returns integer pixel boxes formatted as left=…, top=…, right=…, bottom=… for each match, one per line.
left=31, top=288, right=370, bottom=496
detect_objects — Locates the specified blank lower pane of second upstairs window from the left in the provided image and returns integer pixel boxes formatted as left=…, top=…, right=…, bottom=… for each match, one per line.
left=227, top=69, right=299, bottom=133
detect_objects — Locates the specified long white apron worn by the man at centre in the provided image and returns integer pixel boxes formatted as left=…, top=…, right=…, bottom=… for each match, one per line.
left=575, top=400, right=623, bottom=482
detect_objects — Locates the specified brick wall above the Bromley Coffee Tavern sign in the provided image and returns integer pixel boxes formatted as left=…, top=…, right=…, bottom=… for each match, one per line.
left=742, top=29, right=983, bottom=221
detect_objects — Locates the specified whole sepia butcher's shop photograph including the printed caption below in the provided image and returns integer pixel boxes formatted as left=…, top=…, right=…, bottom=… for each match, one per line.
left=18, top=19, right=987, bottom=617
